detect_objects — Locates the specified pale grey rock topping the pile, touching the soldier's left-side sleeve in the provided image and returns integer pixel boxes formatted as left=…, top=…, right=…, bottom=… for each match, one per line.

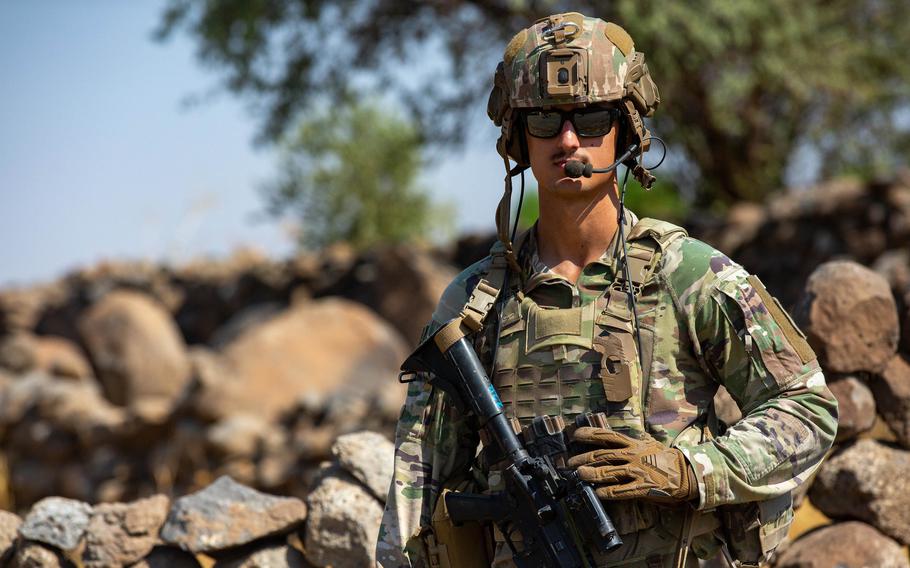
left=332, top=432, right=395, bottom=503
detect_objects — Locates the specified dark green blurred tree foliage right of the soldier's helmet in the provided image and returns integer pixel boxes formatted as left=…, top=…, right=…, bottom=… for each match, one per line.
left=614, top=0, right=910, bottom=202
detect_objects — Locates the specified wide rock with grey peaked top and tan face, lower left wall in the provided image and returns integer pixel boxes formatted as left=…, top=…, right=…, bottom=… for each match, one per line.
left=161, top=476, right=306, bottom=553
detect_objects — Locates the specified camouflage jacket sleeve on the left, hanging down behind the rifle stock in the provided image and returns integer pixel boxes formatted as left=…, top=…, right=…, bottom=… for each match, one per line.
left=376, top=265, right=492, bottom=568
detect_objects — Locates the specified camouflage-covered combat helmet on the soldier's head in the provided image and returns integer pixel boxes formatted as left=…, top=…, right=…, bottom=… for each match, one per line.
left=487, top=12, right=660, bottom=166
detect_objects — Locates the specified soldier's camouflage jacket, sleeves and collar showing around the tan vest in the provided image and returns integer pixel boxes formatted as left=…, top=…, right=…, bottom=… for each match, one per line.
left=377, top=216, right=837, bottom=567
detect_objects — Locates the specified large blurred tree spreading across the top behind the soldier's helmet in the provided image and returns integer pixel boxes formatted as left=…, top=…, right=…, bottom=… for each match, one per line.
left=159, top=0, right=910, bottom=203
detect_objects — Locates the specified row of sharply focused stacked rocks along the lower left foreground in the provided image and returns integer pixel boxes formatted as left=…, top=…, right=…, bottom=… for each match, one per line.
left=0, top=432, right=392, bottom=568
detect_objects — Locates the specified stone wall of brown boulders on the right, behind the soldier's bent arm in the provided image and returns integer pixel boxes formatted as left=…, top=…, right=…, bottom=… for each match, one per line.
left=698, top=174, right=910, bottom=568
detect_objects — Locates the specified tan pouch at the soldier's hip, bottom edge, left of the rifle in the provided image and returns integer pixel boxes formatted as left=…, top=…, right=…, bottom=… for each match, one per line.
left=432, top=489, right=490, bottom=568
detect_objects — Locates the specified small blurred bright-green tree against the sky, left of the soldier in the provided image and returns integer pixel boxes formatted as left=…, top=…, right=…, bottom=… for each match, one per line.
left=263, top=103, right=446, bottom=248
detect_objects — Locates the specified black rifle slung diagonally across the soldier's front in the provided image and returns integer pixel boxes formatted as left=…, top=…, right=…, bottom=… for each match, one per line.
left=399, top=325, right=622, bottom=568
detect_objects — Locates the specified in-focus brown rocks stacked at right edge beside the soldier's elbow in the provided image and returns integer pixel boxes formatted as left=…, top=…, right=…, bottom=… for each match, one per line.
left=774, top=261, right=910, bottom=568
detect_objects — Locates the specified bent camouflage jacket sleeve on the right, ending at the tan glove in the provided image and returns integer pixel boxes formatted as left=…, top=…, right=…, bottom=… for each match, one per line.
left=681, top=249, right=837, bottom=509
